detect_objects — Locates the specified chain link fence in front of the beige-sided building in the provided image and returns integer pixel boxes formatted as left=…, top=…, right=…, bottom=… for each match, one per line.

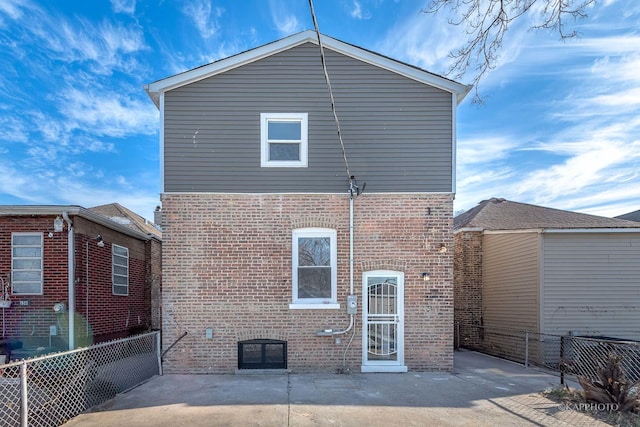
left=456, top=323, right=640, bottom=382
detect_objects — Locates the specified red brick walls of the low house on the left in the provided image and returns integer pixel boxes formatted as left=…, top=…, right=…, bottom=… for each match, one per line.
left=0, top=215, right=160, bottom=349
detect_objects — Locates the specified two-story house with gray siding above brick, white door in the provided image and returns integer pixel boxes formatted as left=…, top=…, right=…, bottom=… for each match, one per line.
left=146, top=31, right=469, bottom=373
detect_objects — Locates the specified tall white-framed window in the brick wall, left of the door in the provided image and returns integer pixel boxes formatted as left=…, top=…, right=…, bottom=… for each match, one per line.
left=289, top=228, right=340, bottom=309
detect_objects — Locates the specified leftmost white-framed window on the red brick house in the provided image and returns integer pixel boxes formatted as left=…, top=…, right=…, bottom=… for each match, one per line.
left=11, top=233, right=43, bottom=295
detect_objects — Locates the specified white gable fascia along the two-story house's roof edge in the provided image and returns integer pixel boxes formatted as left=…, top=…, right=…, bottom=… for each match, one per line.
left=144, top=30, right=472, bottom=107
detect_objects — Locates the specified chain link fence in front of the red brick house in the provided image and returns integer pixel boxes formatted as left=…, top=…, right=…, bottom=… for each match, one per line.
left=0, top=332, right=162, bottom=427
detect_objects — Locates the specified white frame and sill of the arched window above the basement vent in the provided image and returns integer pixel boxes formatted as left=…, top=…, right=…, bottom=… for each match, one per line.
left=289, top=228, right=340, bottom=310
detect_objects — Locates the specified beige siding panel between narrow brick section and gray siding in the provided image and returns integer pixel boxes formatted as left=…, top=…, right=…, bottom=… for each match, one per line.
left=482, top=233, right=540, bottom=332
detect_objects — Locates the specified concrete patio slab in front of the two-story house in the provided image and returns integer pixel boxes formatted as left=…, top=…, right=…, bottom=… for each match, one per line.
left=65, top=351, right=604, bottom=427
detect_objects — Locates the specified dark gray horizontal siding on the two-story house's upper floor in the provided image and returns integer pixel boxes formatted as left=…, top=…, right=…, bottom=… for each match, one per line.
left=163, top=43, right=453, bottom=193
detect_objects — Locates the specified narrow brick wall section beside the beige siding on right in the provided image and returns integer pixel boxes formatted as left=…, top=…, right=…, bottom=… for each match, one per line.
left=453, top=231, right=482, bottom=348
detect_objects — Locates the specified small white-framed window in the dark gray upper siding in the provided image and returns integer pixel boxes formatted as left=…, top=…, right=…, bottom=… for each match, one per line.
left=260, top=113, right=309, bottom=168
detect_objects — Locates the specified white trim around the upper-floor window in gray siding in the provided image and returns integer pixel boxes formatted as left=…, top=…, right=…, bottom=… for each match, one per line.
left=260, top=113, right=309, bottom=168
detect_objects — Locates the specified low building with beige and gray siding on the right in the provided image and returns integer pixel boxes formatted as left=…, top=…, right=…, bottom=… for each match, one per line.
left=454, top=198, right=640, bottom=347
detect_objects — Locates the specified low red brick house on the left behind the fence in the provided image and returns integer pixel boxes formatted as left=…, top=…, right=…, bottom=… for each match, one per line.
left=0, top=204, right=162, bottom=358
